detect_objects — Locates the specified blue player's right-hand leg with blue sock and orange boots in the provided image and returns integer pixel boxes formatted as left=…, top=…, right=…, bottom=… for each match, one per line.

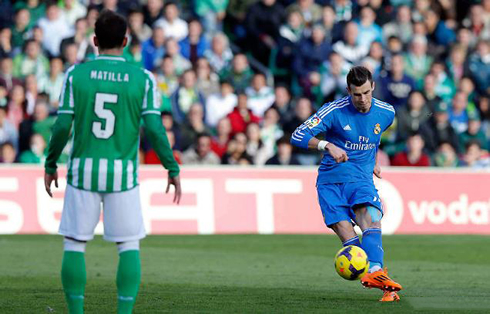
left=354, top=206, right=402, bottom=301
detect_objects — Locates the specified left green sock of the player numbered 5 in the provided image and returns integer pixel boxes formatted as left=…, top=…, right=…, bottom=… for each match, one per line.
left=61, top=251, right=87, bottom=314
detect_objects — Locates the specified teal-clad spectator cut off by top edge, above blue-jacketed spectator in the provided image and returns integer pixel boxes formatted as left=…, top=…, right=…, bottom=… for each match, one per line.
left=194, top=0, right=228, bottom=40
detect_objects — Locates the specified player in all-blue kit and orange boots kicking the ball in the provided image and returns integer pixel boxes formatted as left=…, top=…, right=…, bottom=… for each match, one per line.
left=291, top=66, right=402, bottom=301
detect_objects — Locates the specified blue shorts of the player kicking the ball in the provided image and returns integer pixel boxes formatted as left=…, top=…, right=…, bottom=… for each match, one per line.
left=317, top=182, right=383, bottom=227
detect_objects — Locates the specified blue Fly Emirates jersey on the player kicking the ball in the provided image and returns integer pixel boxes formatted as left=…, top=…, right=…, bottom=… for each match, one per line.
left=291, top=97, right=395, bottom=185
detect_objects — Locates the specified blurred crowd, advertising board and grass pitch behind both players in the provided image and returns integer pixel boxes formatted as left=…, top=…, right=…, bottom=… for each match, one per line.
left=0, top=0, right=490, bottom=313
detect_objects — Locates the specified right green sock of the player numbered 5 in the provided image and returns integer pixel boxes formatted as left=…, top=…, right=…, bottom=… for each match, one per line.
left=117, top=250, right=141, bottom=314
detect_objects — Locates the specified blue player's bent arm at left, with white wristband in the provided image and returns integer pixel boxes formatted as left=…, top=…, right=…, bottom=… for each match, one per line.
left=291, top=109, right=349, bottom=163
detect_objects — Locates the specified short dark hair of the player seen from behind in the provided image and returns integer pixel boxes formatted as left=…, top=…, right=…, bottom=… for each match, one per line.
left=95, top=10, right=128, bottom=49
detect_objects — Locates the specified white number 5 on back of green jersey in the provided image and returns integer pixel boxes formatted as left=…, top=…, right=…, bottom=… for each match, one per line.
left=92, top=93, right=117, bottom=140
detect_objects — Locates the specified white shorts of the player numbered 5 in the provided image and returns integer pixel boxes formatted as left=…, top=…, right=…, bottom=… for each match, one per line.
left=59, top=185, right=146, bottom=242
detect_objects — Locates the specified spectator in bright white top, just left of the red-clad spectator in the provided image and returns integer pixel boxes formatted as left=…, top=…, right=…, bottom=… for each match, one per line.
left=206, top=81, right=237, bottom=129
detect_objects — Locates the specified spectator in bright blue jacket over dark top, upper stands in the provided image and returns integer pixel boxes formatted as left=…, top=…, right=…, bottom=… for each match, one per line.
left=179, top=20, right=209, bottom=65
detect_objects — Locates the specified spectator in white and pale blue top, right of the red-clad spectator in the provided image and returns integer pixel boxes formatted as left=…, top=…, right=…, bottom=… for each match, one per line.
left=245, top=73, right=274, bottom=117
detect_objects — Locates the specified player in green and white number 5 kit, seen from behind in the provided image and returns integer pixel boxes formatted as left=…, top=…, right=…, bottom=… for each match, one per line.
left=44, top=11, right=182, bottom=313
